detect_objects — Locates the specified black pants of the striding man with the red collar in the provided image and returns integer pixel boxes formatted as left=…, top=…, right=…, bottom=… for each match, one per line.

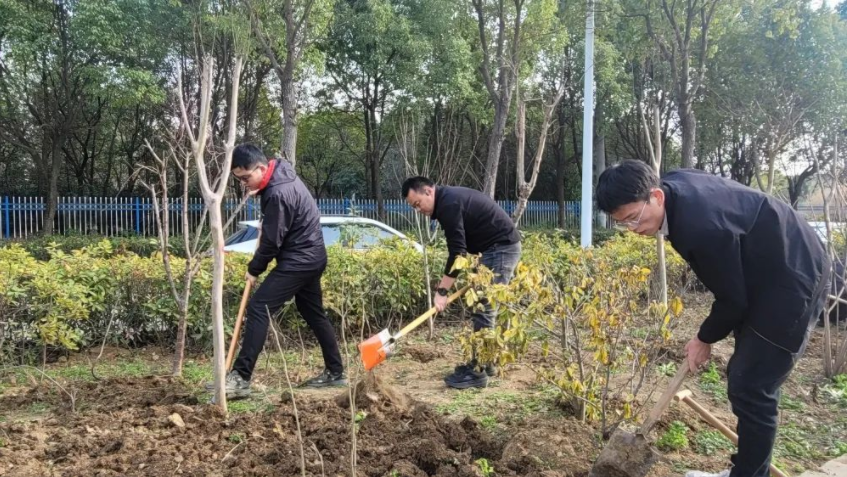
left=233, top=267, right=344, bottom=380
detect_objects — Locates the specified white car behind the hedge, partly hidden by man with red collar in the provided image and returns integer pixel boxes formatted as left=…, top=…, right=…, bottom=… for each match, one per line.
left=224, top=215, right=423, bottom=254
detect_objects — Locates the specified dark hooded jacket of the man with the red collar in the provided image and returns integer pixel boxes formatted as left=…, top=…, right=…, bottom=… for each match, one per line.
left=247, top=161, right=326, bottom=277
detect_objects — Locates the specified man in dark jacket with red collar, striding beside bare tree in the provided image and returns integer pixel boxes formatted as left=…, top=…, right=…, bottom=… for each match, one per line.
left=220, top=144, right=347, bottom=397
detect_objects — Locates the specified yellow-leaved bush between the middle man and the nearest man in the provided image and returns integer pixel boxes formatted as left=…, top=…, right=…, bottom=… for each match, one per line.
left=461, top=234, right=686, bottom=432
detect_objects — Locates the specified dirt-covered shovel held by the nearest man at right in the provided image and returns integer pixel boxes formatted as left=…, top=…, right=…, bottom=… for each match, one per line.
left=588, top=359, right=688, bottom=477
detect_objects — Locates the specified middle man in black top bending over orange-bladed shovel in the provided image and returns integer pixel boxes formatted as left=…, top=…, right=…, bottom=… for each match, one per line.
left=403, top=177, right=521, bottom=389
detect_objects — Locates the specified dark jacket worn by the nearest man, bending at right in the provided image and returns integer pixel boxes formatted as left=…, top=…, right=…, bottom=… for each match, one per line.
left=662, top=170, right=831, bottom=353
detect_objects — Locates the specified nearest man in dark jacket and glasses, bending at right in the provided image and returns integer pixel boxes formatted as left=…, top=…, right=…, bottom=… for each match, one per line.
left=597, top=160, right=831, bottom=477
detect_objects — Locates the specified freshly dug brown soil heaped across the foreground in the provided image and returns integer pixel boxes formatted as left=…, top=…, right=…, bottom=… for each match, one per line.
left=0, top=376, right=596, bottom=477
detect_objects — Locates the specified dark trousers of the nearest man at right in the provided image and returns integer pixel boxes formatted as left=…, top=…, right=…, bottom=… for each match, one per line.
left=727, top=308, right=817, bottom=477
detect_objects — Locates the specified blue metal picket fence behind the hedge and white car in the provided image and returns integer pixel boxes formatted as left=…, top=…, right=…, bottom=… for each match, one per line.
left=0, top=196, right=580, bottom=238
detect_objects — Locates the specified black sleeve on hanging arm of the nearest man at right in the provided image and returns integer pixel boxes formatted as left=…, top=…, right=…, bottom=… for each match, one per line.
left=695, top=231, right=748, bottom=344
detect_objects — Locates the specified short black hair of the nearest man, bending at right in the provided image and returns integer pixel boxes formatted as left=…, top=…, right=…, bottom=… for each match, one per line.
left=594, top=159, right=659, bottom=214
